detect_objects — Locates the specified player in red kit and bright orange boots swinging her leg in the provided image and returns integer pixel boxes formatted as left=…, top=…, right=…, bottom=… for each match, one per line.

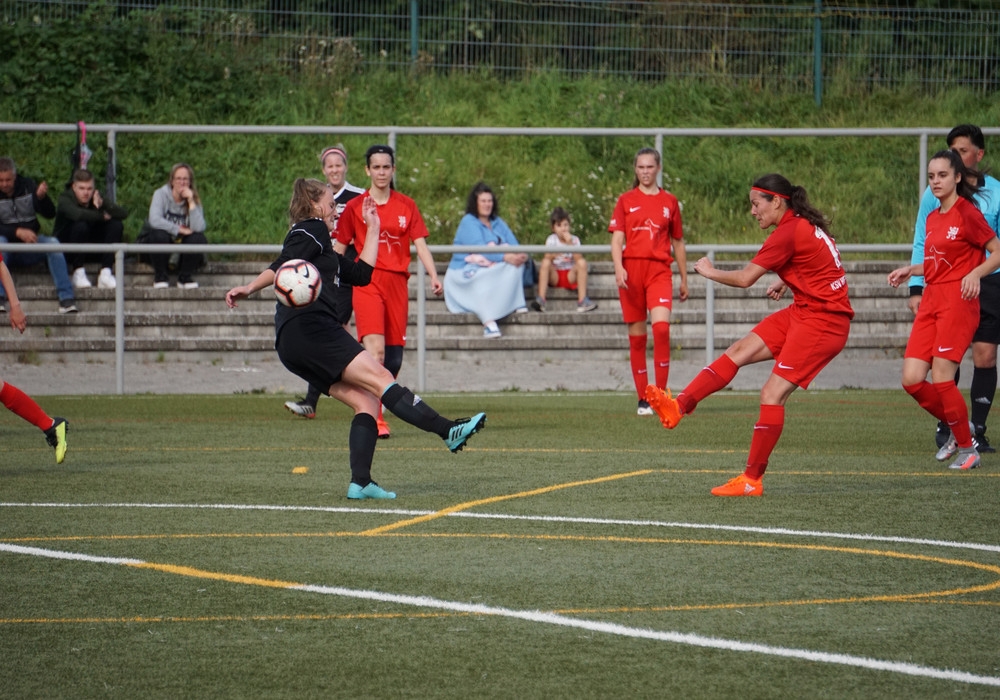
left=646, top=173, right=854, bottom=496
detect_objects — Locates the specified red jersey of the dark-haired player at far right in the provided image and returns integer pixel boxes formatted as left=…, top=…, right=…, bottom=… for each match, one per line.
left=924, top=197, right=997, bottom=284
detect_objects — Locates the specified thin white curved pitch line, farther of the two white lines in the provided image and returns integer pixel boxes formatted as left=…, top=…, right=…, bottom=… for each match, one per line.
left=0, top=502, right=1000, bottom=553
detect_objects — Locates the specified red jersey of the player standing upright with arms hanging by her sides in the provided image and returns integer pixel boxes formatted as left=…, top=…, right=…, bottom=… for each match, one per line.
left=608, top=187, right=684, bottom=265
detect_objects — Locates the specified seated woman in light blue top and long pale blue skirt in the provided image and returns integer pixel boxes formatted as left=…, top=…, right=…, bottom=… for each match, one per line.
left=444, top=182, right=528, bottom=338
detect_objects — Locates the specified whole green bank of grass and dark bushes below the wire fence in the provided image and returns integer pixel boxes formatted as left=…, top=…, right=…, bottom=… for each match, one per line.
left=0, top=8, right=1000, bottom=249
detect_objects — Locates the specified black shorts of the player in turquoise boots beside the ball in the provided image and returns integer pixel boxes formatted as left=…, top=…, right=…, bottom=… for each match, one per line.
left=274, top=314, right=364, bottom=395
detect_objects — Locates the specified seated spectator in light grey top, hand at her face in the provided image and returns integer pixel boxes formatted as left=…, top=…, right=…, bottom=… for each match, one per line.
left=140, top=163, right=208, bottom=289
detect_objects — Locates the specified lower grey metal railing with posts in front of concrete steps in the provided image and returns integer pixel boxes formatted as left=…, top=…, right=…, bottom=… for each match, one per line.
left=0, top=243, right=912, bottom=394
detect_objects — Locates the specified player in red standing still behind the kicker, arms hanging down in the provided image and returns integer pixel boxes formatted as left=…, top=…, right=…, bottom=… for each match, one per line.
left=608, top=148, right=688, bottom=416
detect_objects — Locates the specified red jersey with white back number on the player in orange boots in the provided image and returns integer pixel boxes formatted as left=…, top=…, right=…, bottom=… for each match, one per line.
left=751, top=209, right=854, bottom=318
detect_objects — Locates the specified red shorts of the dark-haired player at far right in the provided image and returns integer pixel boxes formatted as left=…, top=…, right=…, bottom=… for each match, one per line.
left=903, top=282, right=979, bottom=362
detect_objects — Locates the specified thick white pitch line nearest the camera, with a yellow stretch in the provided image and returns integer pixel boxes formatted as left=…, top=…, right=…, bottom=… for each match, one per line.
left=0, top=542, right=1000, bottom=687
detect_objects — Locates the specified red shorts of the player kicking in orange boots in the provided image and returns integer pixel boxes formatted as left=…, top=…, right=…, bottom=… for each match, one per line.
left=753, top=304, right=851, bottom=389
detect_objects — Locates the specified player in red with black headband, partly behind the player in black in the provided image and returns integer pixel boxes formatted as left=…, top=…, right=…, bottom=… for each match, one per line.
left=334, top=145, right=444, bottom=438
